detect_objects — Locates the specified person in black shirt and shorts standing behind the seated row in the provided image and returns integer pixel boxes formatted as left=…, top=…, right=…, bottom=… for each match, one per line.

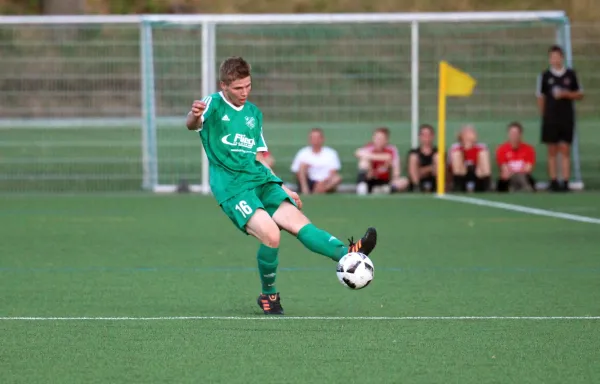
left=537, top=45, right=583, bottom=192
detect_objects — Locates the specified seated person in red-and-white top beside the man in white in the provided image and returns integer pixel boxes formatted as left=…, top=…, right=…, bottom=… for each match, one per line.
left=354, top=128, right=408, bottom=195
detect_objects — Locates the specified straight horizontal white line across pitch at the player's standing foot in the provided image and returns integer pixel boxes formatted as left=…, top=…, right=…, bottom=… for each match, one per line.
left=0, top=316, right=600, bottom=321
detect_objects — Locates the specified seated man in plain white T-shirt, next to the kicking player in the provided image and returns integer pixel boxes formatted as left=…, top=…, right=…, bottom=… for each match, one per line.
left=291, top=128, right=342, bottom=194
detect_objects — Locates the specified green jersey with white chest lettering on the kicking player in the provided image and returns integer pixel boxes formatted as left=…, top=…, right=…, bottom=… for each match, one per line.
left=198, top=92, right=282, bottom=204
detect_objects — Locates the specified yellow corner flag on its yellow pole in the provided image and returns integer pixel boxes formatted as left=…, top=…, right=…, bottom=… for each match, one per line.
left=437, top=61, right=476, bottom=195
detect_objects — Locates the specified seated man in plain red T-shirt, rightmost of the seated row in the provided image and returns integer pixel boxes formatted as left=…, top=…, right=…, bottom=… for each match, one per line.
left=496, top=122, right=535, bottom=192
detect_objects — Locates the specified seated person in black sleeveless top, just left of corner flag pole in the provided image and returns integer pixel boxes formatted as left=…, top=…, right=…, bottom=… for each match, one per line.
left=408, top=124, right=437, bottom=192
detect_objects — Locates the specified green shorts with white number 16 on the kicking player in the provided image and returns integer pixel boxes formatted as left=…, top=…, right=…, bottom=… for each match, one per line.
left=221, top=182, right=296, bottom=234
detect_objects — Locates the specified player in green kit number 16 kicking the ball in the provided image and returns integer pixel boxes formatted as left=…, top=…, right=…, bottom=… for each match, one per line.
left=186, top=57, right=377, bottom=315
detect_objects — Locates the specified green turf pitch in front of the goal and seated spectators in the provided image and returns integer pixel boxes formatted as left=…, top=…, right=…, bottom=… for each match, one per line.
left=0, top=194, right=600, bottom=384
